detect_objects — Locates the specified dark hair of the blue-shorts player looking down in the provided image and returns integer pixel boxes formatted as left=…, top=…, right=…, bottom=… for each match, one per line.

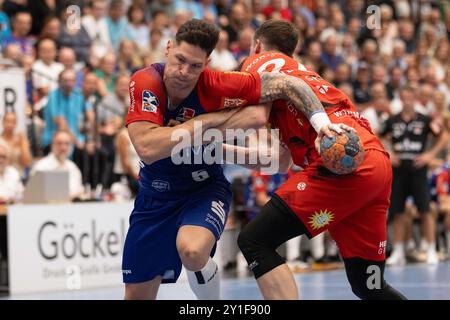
left=175, top=19, right=219, bottom=56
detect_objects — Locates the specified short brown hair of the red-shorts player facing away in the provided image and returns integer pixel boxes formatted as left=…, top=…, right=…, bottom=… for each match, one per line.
left=254, top=19, right=299, bottom=56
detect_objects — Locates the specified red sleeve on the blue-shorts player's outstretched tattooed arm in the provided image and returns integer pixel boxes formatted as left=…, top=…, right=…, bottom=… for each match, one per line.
left=197, top=69, right=261, bottom=112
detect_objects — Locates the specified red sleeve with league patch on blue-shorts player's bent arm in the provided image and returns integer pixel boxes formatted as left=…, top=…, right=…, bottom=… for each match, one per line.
left=125, top=66, right=166, bottom=126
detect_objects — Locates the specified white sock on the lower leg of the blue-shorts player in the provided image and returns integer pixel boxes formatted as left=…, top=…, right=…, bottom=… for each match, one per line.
left=186, top=258, right=220, bottom=300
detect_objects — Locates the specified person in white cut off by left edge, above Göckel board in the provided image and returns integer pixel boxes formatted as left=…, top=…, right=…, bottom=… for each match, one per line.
left=0, top=140, right=23, bottom=205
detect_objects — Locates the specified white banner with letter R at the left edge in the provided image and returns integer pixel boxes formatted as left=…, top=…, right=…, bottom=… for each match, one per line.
left=0, top=68, right=27, bottom=132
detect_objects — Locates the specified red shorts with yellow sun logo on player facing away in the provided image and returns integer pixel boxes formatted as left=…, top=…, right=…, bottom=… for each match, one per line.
left=275, top=150, right=392, bottom=261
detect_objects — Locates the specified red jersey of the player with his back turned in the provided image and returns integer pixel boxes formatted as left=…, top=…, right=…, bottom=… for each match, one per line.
left=242, top=51, right=384, bottom=166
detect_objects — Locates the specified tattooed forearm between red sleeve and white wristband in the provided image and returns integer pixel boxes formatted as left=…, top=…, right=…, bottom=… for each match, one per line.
left=259, top=72, right=324, bottom=119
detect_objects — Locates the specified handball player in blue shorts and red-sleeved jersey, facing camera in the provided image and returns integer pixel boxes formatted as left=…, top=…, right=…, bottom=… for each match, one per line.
left=122, top=19, right=342, bottom=299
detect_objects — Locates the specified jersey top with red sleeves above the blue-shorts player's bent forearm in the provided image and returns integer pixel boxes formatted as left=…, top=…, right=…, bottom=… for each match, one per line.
left=125, top=64, right=261, bottom=126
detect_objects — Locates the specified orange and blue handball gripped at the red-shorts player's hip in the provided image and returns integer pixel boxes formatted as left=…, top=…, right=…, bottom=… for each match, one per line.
left=320, top=130, right=364, bottom=174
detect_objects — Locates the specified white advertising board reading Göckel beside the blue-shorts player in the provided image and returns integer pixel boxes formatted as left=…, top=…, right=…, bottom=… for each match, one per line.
left=8, top=202, right=133, bottom=294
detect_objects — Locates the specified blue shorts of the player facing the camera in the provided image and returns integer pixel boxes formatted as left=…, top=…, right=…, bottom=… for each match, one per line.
left=122, top=178, right=231, bottom=283
